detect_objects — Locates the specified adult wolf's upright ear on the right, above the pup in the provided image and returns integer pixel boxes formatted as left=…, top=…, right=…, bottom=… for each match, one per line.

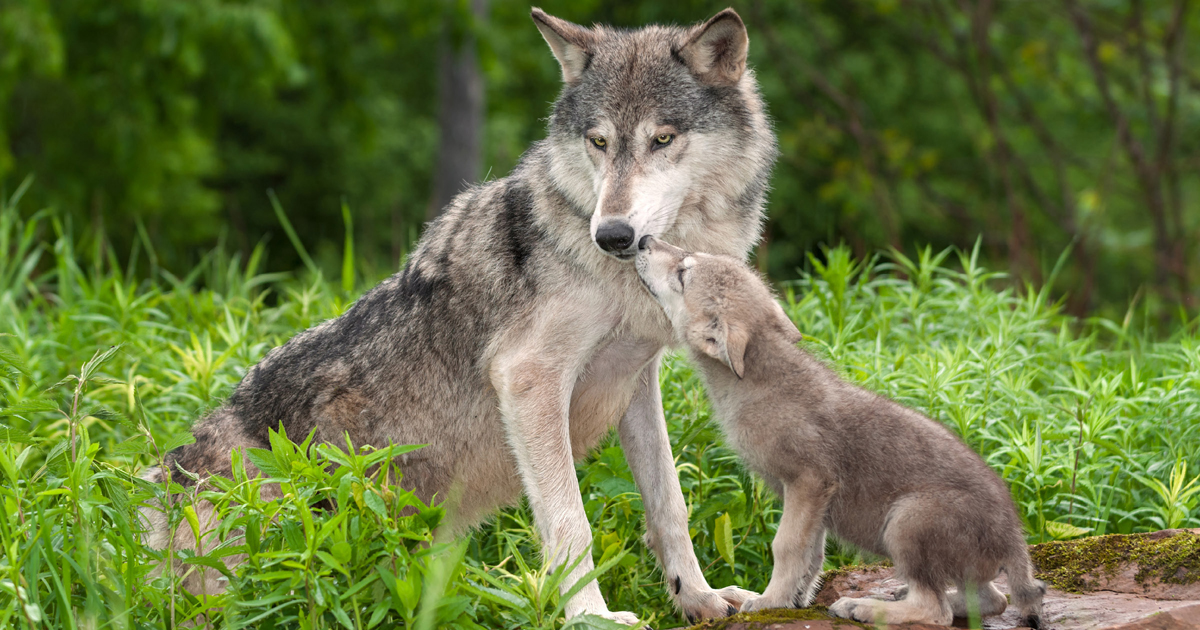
left=679, top=8, right=750, bottom=85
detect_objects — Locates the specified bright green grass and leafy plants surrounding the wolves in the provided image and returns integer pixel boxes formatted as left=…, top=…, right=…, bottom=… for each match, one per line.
left=0, top=191, right=1200, bottom=629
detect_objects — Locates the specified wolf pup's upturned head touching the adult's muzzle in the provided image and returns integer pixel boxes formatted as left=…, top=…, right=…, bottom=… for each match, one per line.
left=637, top=236, right=803, bottom=378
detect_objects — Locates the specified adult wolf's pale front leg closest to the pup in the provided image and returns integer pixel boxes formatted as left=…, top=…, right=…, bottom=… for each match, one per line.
left=618, top=356, right=755, bottom=620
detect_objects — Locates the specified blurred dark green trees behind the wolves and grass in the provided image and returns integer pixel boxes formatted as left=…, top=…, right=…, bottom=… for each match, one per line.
left=0, top=0, right=1200, bottom=313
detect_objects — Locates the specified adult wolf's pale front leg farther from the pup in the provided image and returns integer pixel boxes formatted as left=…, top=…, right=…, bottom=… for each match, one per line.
left=492, top=352, right=637, bottom=625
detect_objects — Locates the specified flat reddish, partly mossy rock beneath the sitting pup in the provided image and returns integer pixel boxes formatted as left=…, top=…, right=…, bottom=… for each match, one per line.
left=676, top=529, right=1200, bottom=630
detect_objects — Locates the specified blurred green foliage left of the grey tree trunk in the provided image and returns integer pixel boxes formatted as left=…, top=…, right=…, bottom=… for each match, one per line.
left=0, top=0, right=446, bottom=269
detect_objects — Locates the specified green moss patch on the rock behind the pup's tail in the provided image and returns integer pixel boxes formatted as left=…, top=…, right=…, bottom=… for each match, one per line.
left=1030, top=530, right=1200, bottom=593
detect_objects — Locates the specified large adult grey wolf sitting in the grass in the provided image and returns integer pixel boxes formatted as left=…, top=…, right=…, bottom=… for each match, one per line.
left=145, top=8, right=776, bottom=624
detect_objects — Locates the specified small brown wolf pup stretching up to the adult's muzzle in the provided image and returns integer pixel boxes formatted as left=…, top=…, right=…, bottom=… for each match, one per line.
left=637, top=236, right=1045, bottom=628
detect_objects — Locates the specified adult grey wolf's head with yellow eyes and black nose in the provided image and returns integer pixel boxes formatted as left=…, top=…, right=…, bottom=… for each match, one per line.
left=533, top=8, right=775, bottom=259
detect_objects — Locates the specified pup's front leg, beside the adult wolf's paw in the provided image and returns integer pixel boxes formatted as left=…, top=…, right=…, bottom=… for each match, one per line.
left=742, top=479, right=834, bottom=612
